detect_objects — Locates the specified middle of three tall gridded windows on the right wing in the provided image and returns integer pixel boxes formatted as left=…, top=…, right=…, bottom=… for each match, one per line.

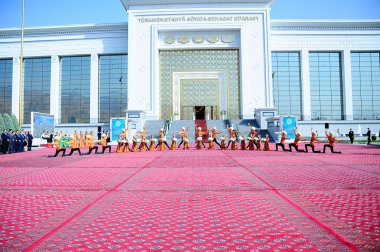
left=309, top=52, right=343, bottom=120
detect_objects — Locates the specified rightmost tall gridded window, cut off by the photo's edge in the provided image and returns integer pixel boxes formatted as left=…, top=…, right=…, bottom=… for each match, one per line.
left=351, top=52, right=380, bottom=120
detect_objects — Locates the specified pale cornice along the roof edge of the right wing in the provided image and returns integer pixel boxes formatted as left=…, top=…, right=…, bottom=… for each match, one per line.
left=270, top=20, right=380, bottom=31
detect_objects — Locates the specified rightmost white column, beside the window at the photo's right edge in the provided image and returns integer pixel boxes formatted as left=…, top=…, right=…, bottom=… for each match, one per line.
left=342, top=49, right=354, bottom=120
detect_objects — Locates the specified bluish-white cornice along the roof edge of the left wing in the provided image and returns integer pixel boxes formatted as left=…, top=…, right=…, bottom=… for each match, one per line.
left=0, top=23, right=128, bottom=38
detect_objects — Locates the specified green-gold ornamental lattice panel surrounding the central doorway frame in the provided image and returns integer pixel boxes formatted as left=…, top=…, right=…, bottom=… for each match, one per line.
left=159, top=49, right=240, bottom=119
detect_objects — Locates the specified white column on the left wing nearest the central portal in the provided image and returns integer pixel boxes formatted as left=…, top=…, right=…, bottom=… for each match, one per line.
left=90, top=53, right=99, bottom=123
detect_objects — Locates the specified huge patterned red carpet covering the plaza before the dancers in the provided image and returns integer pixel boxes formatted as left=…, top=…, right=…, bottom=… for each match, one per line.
left=0, top=144, right=380, bottom=251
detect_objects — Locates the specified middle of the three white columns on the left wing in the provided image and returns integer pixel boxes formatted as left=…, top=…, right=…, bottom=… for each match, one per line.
left=50, top=55, right=60, bottom=124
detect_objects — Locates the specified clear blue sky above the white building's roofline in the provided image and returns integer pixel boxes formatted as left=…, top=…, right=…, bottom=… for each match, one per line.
left=0, top=0, right=380, bottom=28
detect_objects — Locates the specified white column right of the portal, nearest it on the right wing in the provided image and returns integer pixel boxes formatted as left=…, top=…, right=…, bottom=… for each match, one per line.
left=301, top=50, right=311, bottom=121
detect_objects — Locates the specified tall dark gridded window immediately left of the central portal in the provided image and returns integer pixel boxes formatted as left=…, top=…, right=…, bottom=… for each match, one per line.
left=99, top=54, right=128, bottom=123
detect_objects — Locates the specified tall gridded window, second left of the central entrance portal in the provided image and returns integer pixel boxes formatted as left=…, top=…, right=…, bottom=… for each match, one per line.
left=60, top=56, right=91, bottom=123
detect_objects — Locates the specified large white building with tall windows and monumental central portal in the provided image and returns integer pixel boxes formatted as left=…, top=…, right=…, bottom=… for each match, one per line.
left=0, top=0, right=380, bottom=135
